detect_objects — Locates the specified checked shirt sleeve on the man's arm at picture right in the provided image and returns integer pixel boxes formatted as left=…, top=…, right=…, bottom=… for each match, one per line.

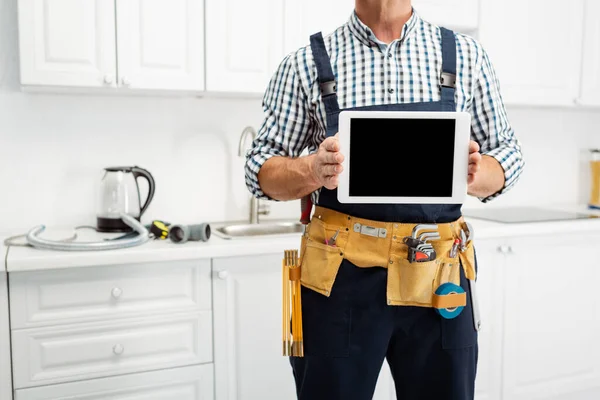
left=471, top=47, right=524, bottom=203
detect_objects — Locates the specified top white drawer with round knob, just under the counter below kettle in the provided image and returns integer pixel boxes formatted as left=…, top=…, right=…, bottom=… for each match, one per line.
left=9, top=260, right=211, bottom=329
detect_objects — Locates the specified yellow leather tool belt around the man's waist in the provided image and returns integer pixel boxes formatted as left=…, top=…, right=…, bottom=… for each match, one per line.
left=300, top=207, right=475, bottom=308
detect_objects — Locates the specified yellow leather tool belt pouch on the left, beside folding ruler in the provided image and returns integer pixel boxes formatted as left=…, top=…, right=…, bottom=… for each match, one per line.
left=300, top=218, right=348, bottom=296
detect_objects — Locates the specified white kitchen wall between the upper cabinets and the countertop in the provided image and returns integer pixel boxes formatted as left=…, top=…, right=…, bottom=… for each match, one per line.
left=0, top=0, right=600, bottom=233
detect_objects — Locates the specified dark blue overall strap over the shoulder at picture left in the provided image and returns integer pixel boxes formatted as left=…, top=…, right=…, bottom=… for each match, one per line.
left=310, top=32, right=340, bottom=136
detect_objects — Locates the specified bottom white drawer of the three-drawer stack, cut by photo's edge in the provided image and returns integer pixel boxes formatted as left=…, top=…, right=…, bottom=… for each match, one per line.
left=15, top=364, right=214, bottom=400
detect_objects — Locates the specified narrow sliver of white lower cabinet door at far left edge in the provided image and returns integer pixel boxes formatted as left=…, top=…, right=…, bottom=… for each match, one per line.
left=0, top=272, right=12, bottom=400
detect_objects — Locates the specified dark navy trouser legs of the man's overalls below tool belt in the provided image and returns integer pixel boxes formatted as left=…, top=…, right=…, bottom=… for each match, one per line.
left=290, top=260, right=478, bottom=400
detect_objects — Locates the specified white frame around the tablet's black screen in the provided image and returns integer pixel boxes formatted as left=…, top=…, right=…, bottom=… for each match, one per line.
left=337, top=111, right=471, bottom=204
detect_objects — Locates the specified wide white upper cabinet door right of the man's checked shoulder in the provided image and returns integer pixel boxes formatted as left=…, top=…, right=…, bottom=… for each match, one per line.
left=479, top=0, right=584, bottom=106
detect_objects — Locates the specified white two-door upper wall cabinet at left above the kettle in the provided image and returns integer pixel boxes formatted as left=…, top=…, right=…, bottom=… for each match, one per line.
left=19, top=0, right=204, bottom=91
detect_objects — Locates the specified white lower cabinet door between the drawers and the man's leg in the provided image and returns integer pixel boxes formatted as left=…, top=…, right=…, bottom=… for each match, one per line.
left=213, top=252, right=296, bottom=400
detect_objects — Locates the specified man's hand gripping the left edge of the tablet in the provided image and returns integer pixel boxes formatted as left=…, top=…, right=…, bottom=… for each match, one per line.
left=311, top=133, right=344, bottom=190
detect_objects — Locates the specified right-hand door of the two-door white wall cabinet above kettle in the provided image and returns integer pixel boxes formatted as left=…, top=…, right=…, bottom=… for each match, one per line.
left=117, top=0, right=204, bottom=91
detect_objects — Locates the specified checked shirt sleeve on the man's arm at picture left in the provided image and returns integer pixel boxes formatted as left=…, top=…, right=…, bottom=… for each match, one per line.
left=245, top=54, right=311, bottom=200
